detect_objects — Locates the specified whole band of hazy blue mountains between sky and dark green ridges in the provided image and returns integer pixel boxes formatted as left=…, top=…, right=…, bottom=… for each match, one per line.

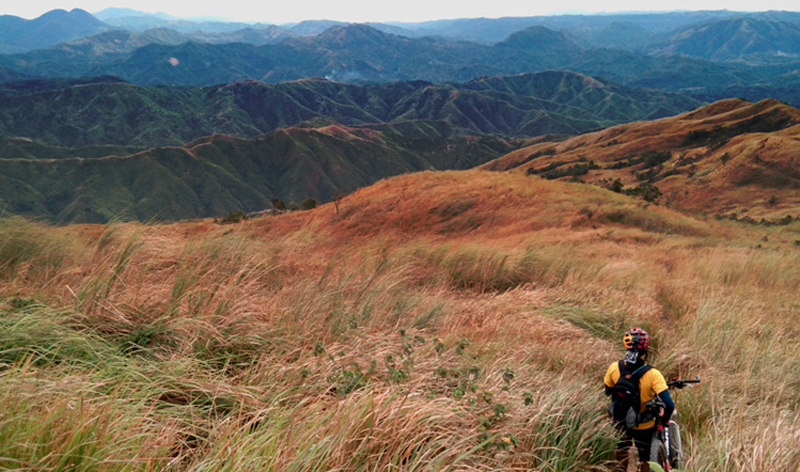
left=0, top=10, right=800, bottom=102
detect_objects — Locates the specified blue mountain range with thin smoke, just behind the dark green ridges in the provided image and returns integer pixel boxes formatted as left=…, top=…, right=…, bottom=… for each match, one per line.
left=0, top=24, right=768, bottom=90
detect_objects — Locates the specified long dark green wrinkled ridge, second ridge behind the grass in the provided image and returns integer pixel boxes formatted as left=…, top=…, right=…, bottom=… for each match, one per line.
left=0, top=71, right=700, bottom=146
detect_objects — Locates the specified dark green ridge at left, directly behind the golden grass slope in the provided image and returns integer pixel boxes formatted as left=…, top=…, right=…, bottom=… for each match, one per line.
left=0, top=122, right=523, bottom=223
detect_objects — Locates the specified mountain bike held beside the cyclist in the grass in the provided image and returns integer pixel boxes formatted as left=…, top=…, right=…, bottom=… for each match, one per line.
left=644, top=377, right=700, bottom=472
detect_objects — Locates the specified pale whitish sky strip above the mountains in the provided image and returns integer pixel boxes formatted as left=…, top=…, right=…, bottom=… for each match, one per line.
left=6, top=0, right=800, bottom=23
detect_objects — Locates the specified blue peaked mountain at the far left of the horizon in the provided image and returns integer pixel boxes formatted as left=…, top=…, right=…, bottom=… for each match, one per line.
left=0, top=8, right=111, bottom=54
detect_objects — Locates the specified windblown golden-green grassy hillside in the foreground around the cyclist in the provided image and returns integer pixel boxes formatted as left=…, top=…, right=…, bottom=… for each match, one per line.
left=0, top=171, right=800, bottom=472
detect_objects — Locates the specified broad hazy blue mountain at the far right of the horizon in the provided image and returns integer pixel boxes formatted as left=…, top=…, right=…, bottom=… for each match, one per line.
left=653, top=17, right=800, bottom=60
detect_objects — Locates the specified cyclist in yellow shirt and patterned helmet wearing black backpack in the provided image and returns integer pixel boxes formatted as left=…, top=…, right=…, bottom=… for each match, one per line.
left=603, top=328, right=675, bottom=472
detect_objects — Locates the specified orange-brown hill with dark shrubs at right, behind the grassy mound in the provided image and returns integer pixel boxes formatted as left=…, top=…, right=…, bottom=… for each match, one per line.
left=483, top=99, right=800, bottom=221
